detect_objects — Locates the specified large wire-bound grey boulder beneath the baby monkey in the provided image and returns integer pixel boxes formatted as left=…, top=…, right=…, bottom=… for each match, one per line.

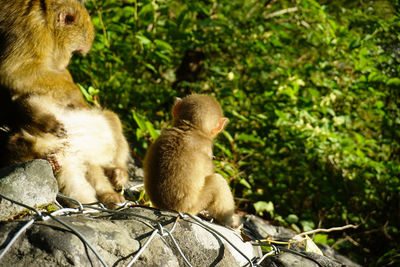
left=0, top=207, right=261, bottom=267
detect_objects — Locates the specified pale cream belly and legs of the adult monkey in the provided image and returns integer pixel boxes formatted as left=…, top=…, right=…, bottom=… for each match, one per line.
left=29, top=96, right=129, bottom=203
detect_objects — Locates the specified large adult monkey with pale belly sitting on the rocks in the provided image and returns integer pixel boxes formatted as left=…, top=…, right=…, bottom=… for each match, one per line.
left=0, top=0, right=129, bottom=207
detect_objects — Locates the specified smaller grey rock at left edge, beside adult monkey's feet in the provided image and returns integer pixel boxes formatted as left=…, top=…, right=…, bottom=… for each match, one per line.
left=0, top=160, right=58, bottom=220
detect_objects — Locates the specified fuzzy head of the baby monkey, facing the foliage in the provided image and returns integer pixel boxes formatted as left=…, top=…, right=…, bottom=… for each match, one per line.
left=172, top=94, right=229, bottom=138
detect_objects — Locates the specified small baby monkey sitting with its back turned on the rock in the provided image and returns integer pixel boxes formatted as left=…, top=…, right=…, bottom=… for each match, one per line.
left=144, top=94, right=234, bottom=226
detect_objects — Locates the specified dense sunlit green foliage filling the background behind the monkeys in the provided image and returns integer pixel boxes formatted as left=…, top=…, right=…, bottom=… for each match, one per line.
left=70, top=0, right=400, bottom=266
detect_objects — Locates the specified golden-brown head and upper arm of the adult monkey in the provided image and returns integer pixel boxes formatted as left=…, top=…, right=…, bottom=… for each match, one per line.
left=0, top=0, right=94, bottom=107
